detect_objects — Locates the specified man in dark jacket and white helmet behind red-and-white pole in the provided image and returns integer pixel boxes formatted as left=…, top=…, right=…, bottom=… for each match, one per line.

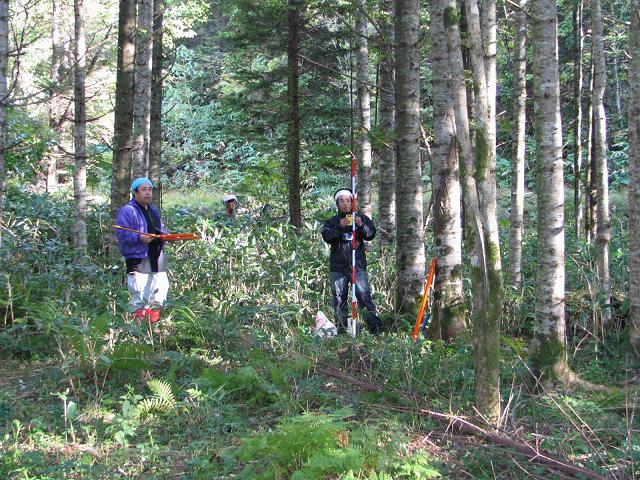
left=322, top=189, right=382, bottom=334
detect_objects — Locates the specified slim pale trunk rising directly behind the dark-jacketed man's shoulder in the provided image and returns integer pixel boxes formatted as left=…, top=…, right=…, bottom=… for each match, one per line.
left=356, top=0, right=371, bottom=218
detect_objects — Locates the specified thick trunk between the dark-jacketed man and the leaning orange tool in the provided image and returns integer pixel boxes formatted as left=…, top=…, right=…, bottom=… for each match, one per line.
left=395, top=0, right=425, bottom=313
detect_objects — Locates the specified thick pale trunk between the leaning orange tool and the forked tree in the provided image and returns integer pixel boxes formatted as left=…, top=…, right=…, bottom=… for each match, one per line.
left=429, top=0, right=465, bottom=340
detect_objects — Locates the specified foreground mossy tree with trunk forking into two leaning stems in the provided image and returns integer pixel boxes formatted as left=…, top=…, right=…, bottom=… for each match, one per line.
left=443, top=0, right=502, bottom=421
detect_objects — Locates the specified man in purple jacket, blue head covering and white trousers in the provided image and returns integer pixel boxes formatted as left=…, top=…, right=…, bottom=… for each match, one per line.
left=116, top=178, right=169, bottom=324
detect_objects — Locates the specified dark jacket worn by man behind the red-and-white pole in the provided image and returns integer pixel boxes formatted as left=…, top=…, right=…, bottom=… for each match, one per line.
left=322, top=213, right=376, bottom=274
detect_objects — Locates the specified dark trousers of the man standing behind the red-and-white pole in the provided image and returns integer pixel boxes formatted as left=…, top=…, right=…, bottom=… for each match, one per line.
left=330, top=270, right=382, bottom=333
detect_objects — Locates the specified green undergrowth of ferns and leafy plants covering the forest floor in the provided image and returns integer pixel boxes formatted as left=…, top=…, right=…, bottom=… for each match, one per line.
left=0, top=186, right=640, bottom=480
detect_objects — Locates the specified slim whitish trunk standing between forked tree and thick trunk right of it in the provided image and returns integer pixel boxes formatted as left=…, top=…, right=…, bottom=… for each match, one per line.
left=509, top=0, right=527, bottom=291
